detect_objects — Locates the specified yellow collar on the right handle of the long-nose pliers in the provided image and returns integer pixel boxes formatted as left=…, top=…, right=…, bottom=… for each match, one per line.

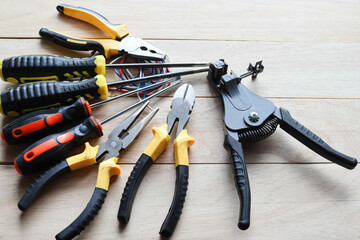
left=96, top=157, right=121, bottom=191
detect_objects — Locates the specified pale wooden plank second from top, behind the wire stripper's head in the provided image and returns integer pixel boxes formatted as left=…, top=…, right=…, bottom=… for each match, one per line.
left=0, top=39, right=360, bottom=98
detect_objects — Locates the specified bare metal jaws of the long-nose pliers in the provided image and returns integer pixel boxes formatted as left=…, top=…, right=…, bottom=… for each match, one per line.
left=96, top=101, right=159, bottom=162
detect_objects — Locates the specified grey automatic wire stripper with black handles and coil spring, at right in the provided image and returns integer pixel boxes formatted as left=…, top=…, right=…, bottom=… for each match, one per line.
left=207, top=60, right=357, bottom=230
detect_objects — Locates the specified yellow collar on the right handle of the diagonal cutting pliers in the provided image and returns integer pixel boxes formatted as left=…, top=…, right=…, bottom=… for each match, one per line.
left=174, top=129, right=195, bottom=167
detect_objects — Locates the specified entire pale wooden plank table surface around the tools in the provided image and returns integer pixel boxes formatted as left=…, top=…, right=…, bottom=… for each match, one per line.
left=0, top=0, right=360, bottom=239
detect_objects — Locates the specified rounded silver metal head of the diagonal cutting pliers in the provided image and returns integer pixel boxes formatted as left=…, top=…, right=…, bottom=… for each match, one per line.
left=167, top=84, right=195, bottom=136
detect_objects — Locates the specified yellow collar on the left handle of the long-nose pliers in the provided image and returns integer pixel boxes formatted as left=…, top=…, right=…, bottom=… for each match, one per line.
left=66, top=142, right=99, bottom=171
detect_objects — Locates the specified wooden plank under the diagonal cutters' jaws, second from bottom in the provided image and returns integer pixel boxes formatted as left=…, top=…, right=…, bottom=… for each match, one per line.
left=0, top=98, right=360, bottom=163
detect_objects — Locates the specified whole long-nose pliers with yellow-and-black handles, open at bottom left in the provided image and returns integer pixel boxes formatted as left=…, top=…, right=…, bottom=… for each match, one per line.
left=18, top=102, right=158, bottom=240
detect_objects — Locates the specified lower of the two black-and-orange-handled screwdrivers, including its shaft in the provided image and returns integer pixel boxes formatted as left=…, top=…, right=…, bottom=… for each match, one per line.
left=14, top=80, right=182, bottom=175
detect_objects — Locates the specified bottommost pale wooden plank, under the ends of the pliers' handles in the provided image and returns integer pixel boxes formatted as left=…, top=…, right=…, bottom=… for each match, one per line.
left=0, top=164, right=360, bottom=239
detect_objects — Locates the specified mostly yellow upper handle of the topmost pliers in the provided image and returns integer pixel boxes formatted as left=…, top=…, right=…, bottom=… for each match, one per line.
left=63, top=6, right=129, bottom=40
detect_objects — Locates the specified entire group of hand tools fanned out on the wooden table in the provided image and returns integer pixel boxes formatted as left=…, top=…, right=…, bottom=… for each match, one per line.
left=0, top=4, right=357, bottom=240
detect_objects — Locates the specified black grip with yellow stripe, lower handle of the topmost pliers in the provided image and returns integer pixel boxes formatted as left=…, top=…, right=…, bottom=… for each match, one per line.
left=39, top=28, right=105, bottom=55
